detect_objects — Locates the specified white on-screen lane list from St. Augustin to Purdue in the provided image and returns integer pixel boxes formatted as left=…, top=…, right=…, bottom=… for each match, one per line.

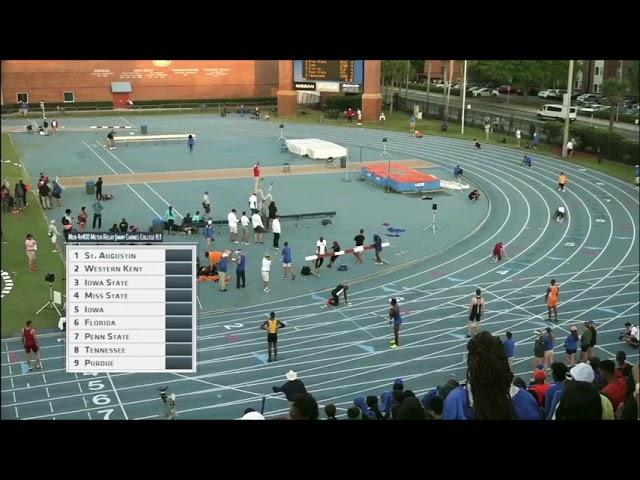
left=66, top=239, right=197, bottom=373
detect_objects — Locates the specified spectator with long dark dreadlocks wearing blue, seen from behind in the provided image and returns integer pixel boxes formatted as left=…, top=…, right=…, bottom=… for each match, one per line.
left=442, top=331, right=540, bottom=420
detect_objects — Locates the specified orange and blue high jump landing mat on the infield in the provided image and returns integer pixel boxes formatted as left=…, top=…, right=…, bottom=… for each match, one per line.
left=360, top=163, right=440, bottom=193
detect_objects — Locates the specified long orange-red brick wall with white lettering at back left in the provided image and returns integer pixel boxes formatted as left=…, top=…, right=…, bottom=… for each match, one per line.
left=2, top=60, right=278, bottom=105
